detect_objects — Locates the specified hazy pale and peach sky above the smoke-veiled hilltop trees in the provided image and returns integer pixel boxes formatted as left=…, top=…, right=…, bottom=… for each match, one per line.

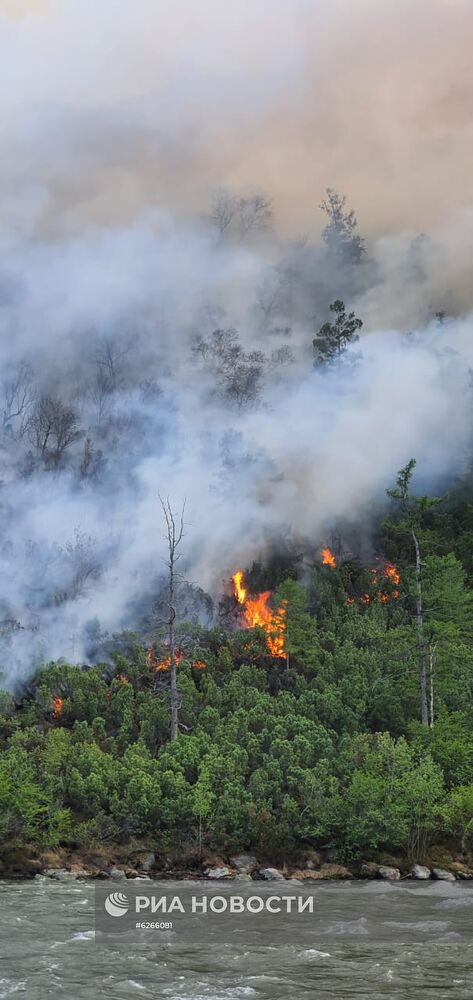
left=0, top=0, right=473, bottom=233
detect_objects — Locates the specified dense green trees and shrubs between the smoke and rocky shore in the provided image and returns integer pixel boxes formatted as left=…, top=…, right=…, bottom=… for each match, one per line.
left=0, top=462, right=473, bottom=859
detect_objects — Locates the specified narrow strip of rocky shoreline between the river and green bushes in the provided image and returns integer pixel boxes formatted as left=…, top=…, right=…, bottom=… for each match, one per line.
left=0, top=846, right=473, bottom=883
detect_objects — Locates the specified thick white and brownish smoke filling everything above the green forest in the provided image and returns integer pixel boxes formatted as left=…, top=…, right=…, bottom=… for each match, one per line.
left=0, top=0, right=473, bottom=684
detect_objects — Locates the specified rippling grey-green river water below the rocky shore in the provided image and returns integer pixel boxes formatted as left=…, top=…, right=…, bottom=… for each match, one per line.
left=0, top=879, right=473, bottom=1000
